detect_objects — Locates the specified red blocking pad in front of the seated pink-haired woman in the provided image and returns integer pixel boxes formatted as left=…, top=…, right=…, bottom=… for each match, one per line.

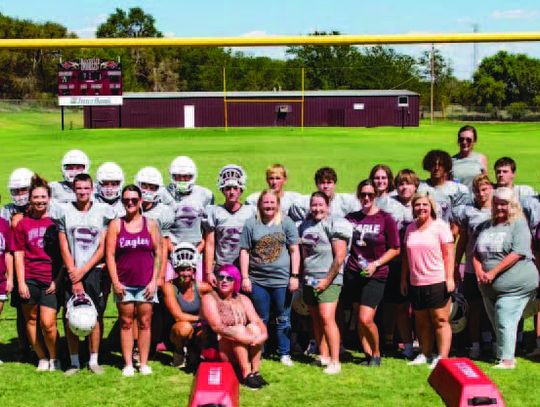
left=189, top=362, right=239, bottom=407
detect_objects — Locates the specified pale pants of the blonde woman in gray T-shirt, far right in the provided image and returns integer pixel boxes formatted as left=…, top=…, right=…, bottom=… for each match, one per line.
left=482, top=290, right=536, bottom=360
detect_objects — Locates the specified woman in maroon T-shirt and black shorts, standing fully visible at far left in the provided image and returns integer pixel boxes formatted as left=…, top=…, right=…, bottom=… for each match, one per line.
left=14, top=175, right=61, bottom=372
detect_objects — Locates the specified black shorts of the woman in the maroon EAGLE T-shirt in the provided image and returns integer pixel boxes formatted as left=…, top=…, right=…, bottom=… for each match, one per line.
left=341, top=270, right=386, bottom=308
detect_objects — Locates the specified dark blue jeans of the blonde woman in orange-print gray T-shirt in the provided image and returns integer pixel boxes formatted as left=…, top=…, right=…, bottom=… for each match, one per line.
left=251, top=281, right=291, bottom=356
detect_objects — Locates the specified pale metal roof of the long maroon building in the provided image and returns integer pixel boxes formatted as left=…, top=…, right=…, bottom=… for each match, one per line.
left=123, top=89, right=419, bottom=99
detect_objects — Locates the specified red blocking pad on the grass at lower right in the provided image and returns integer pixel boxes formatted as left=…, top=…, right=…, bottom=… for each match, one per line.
left=428, top=358, right=504, bottom=407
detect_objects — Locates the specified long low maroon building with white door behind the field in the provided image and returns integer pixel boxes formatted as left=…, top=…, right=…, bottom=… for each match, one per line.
left=84, top=90, right=420, bottom=128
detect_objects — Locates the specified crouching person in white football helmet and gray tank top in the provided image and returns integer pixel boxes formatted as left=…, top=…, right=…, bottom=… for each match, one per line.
left=163, top=242, right=212, bottom=370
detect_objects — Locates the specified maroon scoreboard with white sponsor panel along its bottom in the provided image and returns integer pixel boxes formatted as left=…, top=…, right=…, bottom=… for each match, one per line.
left=58, top=58, right=122, bottom=106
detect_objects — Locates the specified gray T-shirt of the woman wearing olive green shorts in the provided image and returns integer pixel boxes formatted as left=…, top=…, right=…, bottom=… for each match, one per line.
left=298, top=217, right=352, bottom=285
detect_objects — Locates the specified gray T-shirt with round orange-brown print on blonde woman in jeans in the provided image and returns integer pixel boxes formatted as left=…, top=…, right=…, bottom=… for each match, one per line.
left=240, top=217, right=298, bottom=287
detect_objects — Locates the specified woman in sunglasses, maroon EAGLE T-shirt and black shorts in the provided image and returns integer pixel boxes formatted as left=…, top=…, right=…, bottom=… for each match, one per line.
left=343, top=179, right=400, bottom=366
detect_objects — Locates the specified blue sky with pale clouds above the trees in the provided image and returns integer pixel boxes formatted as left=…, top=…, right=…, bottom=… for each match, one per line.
left=0, top=0, right=540, bottom=79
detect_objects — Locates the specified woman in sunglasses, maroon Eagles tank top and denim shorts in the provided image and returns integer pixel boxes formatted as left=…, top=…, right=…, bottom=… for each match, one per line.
left=106, top=185, right=161, bottom=377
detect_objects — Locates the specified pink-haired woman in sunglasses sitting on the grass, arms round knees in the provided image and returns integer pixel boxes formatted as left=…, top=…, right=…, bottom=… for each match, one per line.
left=202, top=264, right=268, bottom=390
